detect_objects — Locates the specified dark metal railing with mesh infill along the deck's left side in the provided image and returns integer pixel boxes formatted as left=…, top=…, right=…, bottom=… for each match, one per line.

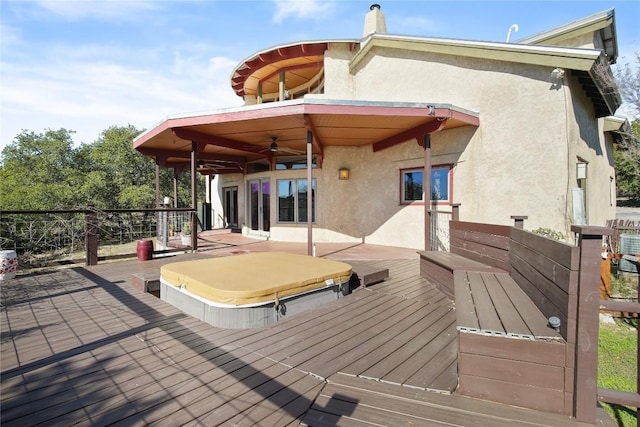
left=0, top=208, right=193, bottom=269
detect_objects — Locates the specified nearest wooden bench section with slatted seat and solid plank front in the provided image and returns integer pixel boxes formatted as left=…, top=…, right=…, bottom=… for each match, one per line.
left=454, top=271, right=566, bottom=413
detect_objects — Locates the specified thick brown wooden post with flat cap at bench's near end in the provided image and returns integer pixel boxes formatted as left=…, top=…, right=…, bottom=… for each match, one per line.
left=571, top=225, right=612, bottom=424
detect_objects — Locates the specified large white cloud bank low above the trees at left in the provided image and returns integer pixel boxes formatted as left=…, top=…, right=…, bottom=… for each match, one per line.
left=0, top=48, right=242, bottom=149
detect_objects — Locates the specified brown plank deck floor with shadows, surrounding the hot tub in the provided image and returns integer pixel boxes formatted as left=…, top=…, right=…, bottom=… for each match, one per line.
left=0, top=255, right=608, bottom=426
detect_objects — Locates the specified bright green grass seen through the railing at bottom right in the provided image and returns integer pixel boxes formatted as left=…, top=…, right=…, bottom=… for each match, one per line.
left=598, top=321, right=638, bottom=427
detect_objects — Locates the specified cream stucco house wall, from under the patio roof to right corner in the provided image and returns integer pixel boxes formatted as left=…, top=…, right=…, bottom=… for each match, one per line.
left=215, top=44, right=615, bottom=249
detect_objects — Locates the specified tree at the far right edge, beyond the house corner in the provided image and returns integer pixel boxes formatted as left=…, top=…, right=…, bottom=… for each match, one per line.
left=614, top=52, right=640, bottom=205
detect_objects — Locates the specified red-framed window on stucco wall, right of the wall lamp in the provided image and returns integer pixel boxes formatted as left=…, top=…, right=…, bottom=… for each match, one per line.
left=400, top=166, right=451, bottom=204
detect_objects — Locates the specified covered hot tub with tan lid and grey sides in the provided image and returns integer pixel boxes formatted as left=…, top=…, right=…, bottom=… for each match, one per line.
left=160, top=252, right=351, bottom=328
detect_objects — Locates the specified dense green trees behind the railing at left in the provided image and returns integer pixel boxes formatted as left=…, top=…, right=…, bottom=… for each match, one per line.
left=0, top=125, right=204, bottom=210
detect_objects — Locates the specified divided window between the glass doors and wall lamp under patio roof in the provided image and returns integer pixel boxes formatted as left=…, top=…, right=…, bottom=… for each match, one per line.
left=278, top=179, right=316, bottom=223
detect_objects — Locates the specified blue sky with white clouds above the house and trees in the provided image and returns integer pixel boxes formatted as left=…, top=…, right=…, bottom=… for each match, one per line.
left=0, top=0, right=640, bottom=150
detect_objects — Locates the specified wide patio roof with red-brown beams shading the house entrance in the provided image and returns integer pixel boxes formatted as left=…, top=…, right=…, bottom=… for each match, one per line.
left=133, top=96, right=479, bottom=173
